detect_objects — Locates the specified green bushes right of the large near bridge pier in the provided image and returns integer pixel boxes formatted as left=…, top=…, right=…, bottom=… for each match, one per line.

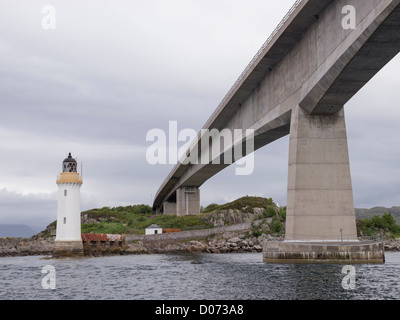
left=357, top=212, right=400, bottom=238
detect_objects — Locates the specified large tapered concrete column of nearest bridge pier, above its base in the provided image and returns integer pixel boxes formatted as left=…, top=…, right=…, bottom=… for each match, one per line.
left=286, top=106, right=357, bottom=242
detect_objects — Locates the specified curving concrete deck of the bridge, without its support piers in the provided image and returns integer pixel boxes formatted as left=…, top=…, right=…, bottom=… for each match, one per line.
left=153, top=0, right=400, bottom=208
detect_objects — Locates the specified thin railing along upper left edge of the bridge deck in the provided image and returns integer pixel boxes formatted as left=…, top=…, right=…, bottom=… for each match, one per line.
left=203, top=0, right=303, bottom=129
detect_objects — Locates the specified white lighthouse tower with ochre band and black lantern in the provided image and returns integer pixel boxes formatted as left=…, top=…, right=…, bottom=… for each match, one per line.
left=53, top=153, right=83, bottom=257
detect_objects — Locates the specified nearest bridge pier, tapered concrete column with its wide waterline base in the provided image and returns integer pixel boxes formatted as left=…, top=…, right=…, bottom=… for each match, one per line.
left=263, top=106, right=384, bottom=263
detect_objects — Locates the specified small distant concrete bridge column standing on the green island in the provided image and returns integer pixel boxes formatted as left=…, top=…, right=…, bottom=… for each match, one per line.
left=176, top=186, right=200, bottom=216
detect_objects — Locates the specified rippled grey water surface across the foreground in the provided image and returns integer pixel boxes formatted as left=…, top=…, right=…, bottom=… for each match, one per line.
left=0, top=253, right=400, bottom=300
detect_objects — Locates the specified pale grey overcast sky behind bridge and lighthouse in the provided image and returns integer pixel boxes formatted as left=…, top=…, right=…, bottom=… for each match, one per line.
left=0, top=0, right=400, bottom=235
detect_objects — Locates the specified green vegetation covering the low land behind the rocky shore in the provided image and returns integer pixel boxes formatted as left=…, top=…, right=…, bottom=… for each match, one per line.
left=77, top=196, right=400, bottom=238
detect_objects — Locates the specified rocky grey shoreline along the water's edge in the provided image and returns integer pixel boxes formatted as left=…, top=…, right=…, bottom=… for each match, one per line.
left=0, top=235, right=400, bottom=257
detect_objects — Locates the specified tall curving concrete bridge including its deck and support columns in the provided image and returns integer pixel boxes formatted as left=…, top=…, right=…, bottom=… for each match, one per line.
left=153, top=0, right=400, bottom=248
